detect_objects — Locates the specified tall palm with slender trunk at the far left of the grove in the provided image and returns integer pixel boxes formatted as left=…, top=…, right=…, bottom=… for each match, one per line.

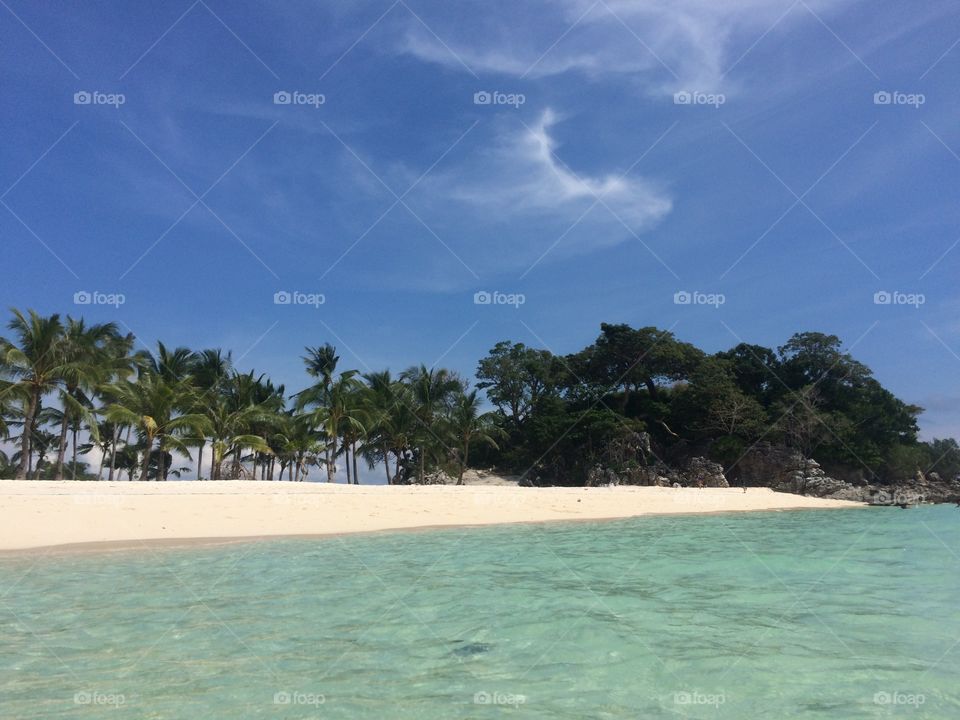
left=0, top=308, right=64, bottom=480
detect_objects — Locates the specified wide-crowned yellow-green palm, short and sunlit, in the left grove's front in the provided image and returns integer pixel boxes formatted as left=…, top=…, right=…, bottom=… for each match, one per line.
left=105, top=371, right=208, bottom=480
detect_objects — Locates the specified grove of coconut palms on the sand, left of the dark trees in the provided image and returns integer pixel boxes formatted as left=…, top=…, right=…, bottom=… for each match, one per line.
left=0, top=309, right=502, bottom=484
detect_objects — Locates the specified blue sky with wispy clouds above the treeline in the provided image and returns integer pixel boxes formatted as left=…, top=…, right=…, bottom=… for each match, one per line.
left=0, top=0, right=960, bottom=438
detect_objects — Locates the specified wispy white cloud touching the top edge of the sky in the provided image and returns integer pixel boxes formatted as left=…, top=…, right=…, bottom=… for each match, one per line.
left=400, top=0, right=854, bottom=91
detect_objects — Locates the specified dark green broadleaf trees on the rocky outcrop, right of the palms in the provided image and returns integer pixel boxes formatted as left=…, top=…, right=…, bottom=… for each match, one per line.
left=478, top=324, right=936, bottom=483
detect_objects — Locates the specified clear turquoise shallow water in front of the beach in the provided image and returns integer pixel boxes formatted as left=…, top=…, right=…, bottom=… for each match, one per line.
left=0, top=507, right=960, bottom=720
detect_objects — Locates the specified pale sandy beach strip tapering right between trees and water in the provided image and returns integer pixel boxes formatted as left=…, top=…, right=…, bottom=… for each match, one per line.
left=0, top=480, right=860, bottom=552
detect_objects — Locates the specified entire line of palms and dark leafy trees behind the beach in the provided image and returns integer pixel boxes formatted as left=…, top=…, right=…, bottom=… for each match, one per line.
left=0, top=310, right=944, bottom=484
